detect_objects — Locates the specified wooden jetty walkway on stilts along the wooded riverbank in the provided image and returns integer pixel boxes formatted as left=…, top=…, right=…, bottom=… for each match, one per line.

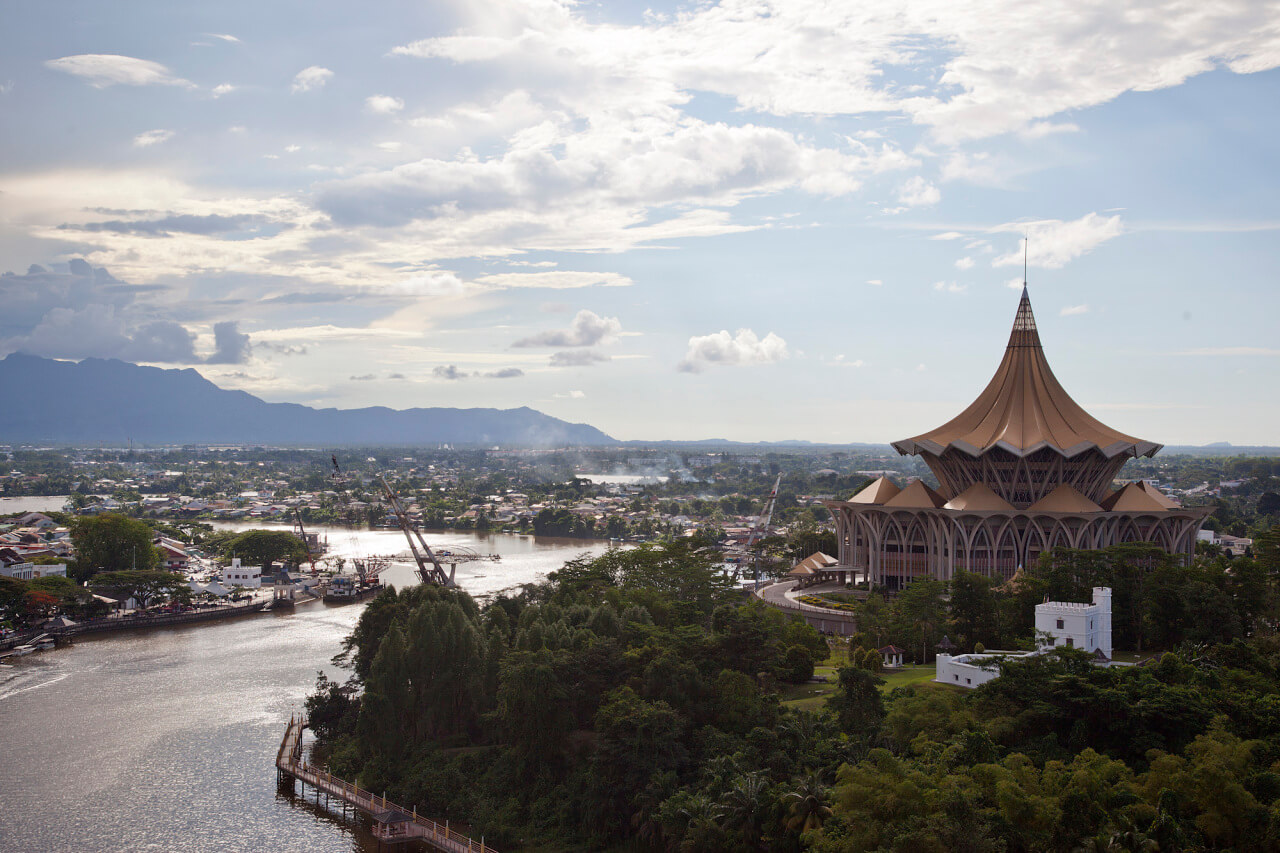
left=275, top=716, right=498, bottom=853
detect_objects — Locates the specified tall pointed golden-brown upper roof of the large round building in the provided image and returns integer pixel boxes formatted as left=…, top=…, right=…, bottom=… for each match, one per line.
left=893, top=287, right=1162, bottom=459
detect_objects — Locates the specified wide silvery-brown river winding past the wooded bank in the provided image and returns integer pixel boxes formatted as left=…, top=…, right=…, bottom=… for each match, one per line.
left=0, top=524, right=607, bottom=853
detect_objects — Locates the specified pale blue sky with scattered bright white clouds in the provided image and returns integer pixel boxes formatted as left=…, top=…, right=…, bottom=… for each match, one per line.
left=0, top=0, right=1280, bottom=444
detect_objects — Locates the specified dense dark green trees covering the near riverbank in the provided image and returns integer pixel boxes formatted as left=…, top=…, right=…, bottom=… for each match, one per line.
left=307, top=542, right=1280, bottom=853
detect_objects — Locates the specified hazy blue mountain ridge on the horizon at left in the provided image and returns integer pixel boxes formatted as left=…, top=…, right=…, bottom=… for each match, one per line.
left=0, top=352, right=617, bottom=447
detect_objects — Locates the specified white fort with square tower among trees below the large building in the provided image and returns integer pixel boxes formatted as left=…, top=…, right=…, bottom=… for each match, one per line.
left=933, top=587, right=1112, bottom=688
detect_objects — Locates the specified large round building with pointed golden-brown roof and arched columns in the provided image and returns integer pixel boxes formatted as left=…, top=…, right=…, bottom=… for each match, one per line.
left=824, top=286, right=1211, bottom=588
